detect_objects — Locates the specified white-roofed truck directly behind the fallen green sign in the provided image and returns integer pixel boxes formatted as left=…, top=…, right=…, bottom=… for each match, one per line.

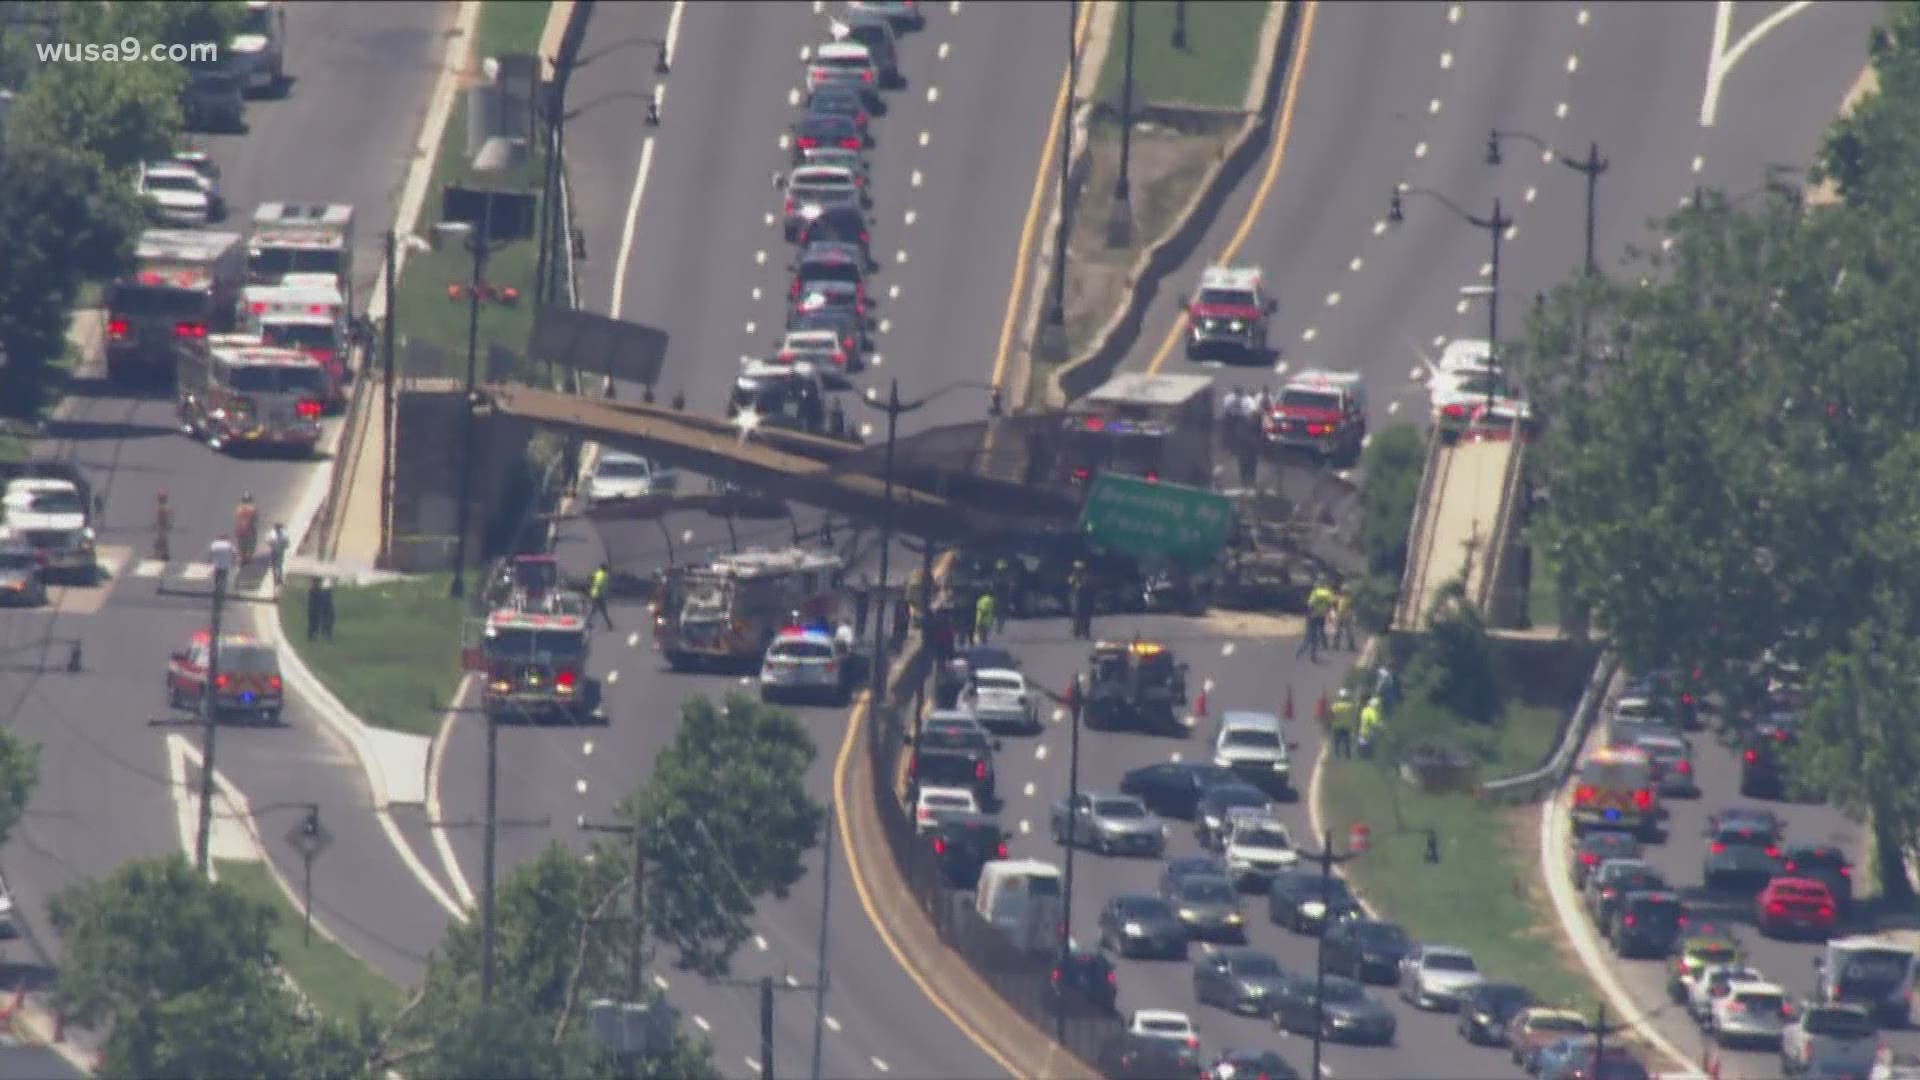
left=1058, top=371, right=1213, bottom=488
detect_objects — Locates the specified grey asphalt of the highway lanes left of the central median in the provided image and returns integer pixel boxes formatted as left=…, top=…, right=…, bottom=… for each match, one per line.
left=438, top=0, right=1068, bottom=1078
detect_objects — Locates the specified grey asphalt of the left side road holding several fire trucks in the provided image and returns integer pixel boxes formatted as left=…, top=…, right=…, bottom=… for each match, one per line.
left=0, top=4, right=453, bottom=982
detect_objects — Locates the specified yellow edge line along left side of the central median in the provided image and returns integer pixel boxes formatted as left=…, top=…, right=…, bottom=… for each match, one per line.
left=833, top=2, right=1092, bottom=1076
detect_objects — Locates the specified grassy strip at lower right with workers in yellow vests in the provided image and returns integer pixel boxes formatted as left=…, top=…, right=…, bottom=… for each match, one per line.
left=1321, top=638, right=1597, bottom=1013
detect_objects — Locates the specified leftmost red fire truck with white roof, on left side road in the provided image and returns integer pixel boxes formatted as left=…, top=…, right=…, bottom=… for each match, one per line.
left=106, top=229, right=246, bottom=384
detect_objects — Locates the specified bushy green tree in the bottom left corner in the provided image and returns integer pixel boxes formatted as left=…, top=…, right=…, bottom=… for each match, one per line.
left=52, top=855, right=365, bottom=1078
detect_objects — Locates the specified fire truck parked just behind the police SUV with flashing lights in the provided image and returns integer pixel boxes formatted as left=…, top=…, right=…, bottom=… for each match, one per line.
left=653, top=548, right=845, bottom=671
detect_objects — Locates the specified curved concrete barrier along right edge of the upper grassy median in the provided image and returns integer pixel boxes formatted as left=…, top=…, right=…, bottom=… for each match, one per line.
left=1048, top=0, right=1304, bottom=402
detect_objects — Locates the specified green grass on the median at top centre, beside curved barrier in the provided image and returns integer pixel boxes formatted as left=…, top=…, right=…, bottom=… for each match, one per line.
left=1098, top=0, right=1267, bottom=110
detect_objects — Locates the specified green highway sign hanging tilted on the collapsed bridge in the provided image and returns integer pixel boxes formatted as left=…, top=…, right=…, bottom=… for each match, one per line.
left=1081, top=473, right=1233, bottom=569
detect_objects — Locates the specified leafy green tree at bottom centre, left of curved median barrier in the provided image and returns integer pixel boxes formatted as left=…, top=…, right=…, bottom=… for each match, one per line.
left=620, top=696, right=826, bottom=976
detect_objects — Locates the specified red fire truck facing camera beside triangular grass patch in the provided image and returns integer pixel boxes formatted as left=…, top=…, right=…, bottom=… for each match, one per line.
left=461, top=603, right=599, bottom=723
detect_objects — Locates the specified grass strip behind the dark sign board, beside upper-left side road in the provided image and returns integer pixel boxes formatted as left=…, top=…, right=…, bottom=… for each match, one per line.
left=396, top=0, right=551, bottom=380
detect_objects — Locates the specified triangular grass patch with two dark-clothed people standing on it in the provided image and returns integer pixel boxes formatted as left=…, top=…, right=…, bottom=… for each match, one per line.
left=280, top=575, right=467, bottom=736
